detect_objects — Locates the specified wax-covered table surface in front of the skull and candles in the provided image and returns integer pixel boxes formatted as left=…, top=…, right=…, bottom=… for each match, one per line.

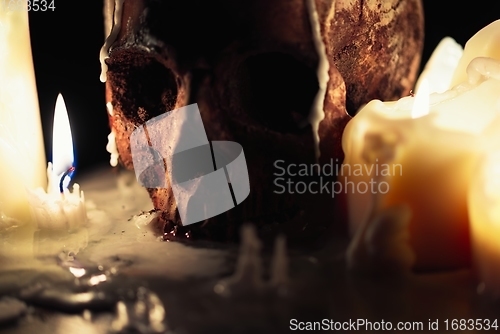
left=0, top=169, right=500, bottom=334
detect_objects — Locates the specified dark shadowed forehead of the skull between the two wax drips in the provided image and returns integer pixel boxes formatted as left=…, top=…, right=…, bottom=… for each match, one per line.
left=125, top=0, right=322, bottom=72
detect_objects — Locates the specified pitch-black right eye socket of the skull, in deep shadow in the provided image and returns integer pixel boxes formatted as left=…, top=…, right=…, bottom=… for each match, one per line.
left=239, top=52, right=319, bottom=133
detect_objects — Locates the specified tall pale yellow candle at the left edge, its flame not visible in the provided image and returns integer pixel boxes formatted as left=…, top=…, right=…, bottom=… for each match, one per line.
left=0, top=6, right=47, bottom=229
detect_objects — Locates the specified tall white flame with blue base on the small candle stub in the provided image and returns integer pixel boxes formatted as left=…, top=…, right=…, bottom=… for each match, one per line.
left=52, top=94, right=74, bottom=191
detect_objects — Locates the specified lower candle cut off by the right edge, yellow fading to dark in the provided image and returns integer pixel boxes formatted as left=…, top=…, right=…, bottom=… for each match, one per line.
left=468, top=150, right=500, bottom=298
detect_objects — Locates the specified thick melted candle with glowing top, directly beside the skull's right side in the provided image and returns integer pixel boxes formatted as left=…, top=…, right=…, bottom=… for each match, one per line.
left=341, top=58, right=500, bottom=269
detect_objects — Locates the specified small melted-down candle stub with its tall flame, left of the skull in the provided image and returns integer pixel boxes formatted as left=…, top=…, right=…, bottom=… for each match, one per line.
left=29, top=94, right=87, bottom=231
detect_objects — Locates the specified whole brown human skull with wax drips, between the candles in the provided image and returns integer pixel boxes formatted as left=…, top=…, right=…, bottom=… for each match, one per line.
left=104, top=0, right=423, bottom=243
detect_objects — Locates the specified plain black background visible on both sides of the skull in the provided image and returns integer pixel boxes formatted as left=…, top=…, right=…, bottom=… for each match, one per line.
left=26, top=0, right=500, bottom=172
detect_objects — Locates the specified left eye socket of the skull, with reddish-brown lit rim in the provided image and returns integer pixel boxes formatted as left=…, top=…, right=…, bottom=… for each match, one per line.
left=107, top=49, right=177, bottom=125
